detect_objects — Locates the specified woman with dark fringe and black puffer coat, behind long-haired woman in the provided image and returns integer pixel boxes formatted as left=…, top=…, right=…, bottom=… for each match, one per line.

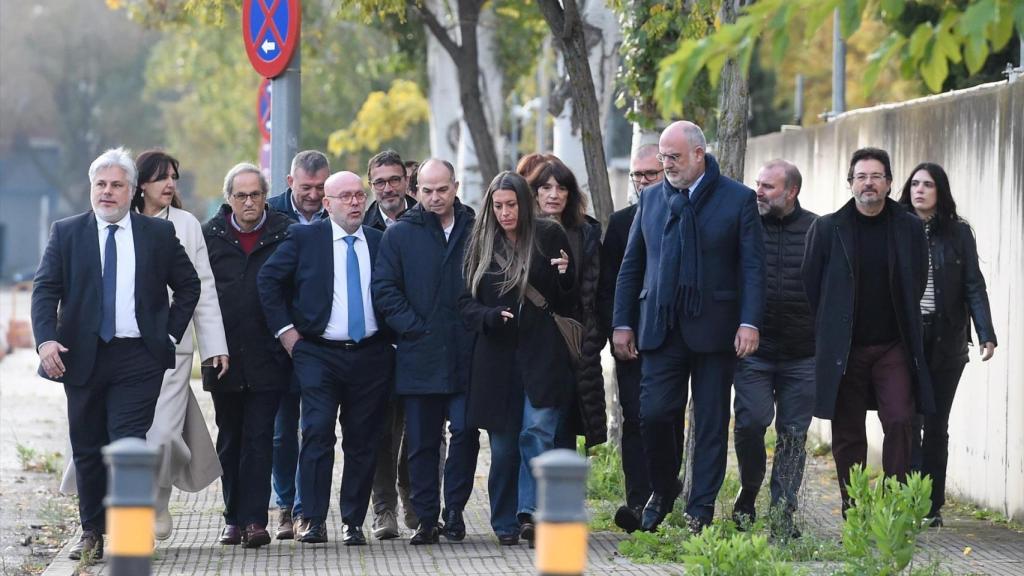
left=520, top=155, right=607, bottom=450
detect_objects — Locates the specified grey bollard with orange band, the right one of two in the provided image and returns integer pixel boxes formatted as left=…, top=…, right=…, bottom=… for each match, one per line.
left=530, top=449, right=590, bottom=576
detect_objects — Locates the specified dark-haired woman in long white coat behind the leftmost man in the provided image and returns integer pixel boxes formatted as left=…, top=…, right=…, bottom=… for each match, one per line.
left=60, top=151, right=228, bottom=540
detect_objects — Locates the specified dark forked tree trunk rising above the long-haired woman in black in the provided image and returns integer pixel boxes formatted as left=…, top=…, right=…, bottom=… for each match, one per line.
left=411, top=0, right=498, bottom=182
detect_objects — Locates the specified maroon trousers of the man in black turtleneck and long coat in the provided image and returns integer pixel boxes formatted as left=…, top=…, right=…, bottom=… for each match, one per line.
left=831, top=341, right=915, bottom=509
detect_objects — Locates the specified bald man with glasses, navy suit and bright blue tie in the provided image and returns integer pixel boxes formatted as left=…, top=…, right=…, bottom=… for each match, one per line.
left=257, top=172, right=394, bottom=545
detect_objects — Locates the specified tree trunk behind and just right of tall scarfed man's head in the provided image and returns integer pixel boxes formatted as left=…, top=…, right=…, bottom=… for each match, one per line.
left=717, top=0, right=750, bottom=181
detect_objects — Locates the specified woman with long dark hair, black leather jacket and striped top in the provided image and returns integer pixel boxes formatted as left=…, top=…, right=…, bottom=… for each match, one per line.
left=899, top=162, right=996, bottom=526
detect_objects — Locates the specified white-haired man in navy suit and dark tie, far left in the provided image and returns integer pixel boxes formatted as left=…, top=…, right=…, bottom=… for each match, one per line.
left=32, top=149, right=200, bottom=560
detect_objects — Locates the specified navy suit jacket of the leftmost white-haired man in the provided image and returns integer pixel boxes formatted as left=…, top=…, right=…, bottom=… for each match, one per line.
left=32, top=211, right=201, bottom=386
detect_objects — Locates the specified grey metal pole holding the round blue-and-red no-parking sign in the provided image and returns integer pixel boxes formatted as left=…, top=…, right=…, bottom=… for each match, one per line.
left=270, top=45, right=302, bottom=196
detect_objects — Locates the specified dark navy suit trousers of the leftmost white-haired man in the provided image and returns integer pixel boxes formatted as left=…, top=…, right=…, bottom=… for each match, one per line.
left=65, top=338, right=165, bottom=533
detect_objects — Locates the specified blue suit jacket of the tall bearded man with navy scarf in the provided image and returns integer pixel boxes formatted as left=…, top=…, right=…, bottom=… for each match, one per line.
left=612, top=154, right=765, bottom=354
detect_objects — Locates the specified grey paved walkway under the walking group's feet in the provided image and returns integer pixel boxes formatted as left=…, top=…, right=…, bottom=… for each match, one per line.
left=37, top=382, right=1024, bottom=576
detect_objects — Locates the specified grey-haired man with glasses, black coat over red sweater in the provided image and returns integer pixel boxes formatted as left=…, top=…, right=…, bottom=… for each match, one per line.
left=203, top=164, right=293, bottom=547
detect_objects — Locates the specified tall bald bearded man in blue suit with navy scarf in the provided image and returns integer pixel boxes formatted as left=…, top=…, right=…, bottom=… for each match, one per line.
left=612, top=121, right=765, bottom=532
